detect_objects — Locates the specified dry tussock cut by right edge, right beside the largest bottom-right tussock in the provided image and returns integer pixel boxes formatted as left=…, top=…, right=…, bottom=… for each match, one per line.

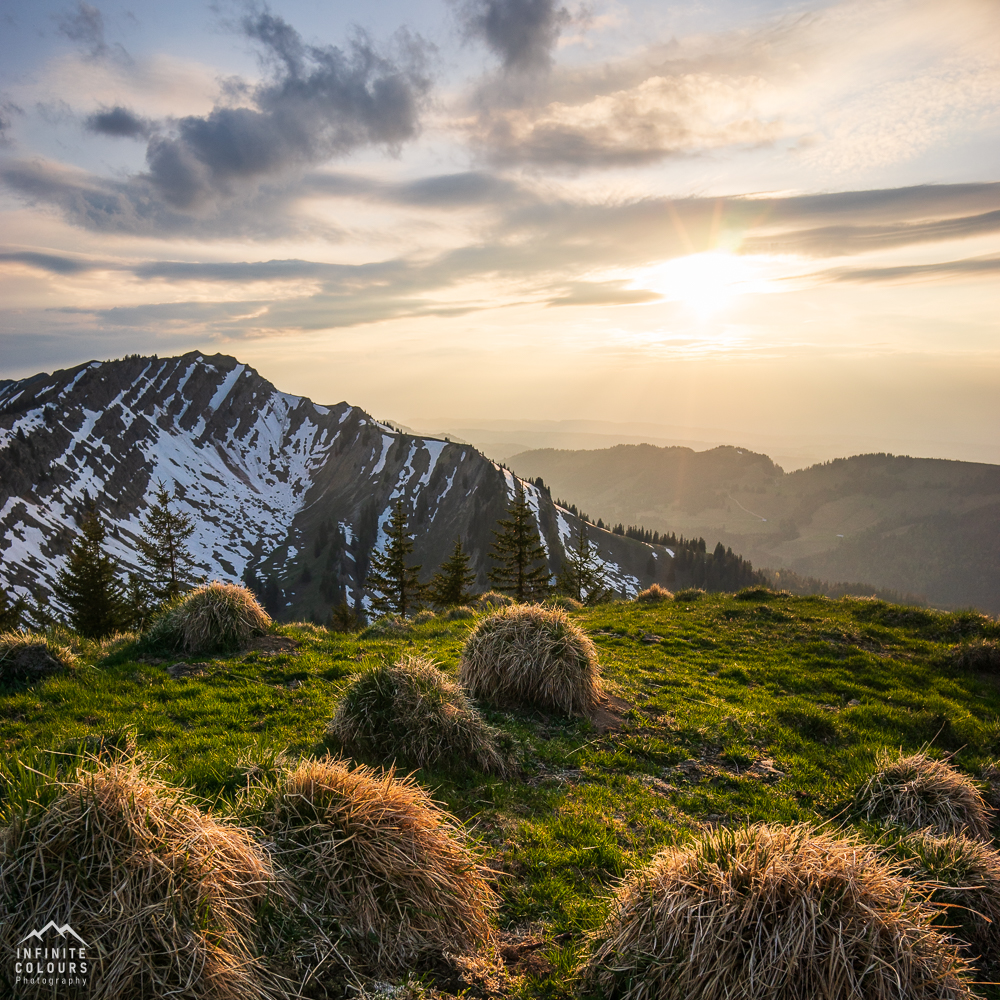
left=893, top=830, right=1000, bottom=963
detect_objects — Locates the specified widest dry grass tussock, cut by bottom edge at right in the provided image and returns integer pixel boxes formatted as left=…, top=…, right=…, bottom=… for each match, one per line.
left=583, top=826, right=973, bottom=1000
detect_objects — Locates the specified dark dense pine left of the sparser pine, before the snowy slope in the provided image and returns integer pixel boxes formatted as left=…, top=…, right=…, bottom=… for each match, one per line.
left=53, top=508, right=123, bottom=639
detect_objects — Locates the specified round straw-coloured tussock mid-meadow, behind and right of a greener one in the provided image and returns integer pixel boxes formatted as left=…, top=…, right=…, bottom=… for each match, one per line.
left=459, top=604, right=604, bottom=715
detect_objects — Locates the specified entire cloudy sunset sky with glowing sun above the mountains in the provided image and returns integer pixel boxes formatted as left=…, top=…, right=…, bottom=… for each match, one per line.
left=0, top=0, right=1000, bottom=463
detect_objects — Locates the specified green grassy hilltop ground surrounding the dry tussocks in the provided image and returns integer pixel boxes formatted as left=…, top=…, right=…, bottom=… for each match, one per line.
left=0, top=590, right=1000, bottom=997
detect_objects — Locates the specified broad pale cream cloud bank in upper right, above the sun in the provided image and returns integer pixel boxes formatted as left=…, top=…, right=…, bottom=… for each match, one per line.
left=465, top=0, right=1000, bottom=174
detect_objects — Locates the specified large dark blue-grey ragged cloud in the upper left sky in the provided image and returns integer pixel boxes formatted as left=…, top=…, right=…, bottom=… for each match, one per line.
left=0, top=12, right=431, bottom=232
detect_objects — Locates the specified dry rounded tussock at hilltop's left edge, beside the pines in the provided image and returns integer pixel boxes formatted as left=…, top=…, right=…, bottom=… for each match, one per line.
left=150, top=580, right=271, bottom=653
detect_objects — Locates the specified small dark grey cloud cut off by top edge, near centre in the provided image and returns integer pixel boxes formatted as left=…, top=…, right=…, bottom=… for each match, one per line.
left=458, top=0, right=572, bottom=72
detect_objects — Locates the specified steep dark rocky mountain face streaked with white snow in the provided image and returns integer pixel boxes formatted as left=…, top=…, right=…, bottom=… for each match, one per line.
left=0, top=352, right=669, bottom=620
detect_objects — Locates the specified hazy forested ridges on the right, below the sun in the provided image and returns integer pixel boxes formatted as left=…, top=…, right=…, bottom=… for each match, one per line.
left=510, top=445, right=1000, bottom=614
